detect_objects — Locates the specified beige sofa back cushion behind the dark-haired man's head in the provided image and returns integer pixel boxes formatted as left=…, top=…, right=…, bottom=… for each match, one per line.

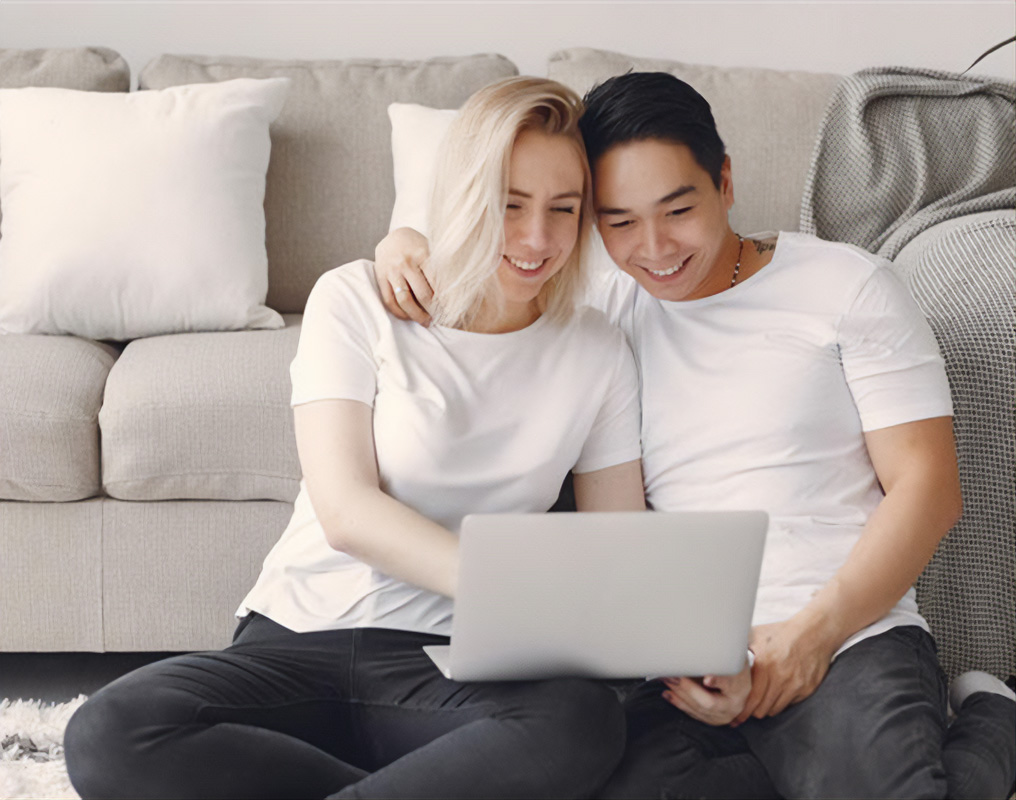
left=548, top=48, right=840, bottom=234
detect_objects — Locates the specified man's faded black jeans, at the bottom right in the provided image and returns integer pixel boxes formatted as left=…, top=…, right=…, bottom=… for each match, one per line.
left=601, top=626, right=1016, bottom=799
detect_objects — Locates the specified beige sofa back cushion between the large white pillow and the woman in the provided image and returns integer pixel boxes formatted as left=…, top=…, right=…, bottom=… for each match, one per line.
left=139, top=55, right=518, bottom=313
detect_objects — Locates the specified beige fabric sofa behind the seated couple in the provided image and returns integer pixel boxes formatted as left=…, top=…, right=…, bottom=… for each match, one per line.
left=0, top=43, right=1014, bottom=675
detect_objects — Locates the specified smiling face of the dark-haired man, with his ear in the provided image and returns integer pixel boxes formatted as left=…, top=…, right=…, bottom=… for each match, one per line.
left=593, top=139, right=738, bottom=300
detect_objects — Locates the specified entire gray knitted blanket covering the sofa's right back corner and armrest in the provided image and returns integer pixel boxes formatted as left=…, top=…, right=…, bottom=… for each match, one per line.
left=801, top=68, right=1016, bottom=678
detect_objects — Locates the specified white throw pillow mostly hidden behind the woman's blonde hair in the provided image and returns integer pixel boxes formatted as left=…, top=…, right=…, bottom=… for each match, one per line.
left=388, top=103, right=458, bottom=236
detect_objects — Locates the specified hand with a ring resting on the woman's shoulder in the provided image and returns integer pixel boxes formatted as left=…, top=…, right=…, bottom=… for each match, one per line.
left=374, top=228, right=434, bottom=325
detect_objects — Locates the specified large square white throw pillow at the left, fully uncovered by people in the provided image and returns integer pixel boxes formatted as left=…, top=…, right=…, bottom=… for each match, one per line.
left=0, top=78, right=290, bottom=340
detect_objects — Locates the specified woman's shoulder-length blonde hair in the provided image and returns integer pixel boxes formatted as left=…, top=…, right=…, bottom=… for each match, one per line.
left=426, top=77, right=592, bottom=327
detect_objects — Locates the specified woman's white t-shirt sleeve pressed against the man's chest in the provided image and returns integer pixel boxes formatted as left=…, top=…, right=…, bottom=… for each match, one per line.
left=573, top=330, right=642, bottom=473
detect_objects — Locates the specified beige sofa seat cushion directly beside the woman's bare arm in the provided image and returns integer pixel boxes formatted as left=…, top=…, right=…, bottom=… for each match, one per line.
left=99, top=314, right=303, bottom=502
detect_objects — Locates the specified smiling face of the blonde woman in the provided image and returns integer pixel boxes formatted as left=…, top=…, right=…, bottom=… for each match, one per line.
left=497, top=130, right=584, bottom=313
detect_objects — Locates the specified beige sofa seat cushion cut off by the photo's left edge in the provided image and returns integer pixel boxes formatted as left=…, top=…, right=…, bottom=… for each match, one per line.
left=0, top=334, right=118, bottom=501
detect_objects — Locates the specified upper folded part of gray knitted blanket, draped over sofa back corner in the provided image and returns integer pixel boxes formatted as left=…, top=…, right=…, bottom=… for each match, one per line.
left=801, top=67, right=1016, bottom=259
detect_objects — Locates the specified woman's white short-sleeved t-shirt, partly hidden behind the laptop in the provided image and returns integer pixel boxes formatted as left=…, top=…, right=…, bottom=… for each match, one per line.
left=237, top=261, right=640, bottom=634
